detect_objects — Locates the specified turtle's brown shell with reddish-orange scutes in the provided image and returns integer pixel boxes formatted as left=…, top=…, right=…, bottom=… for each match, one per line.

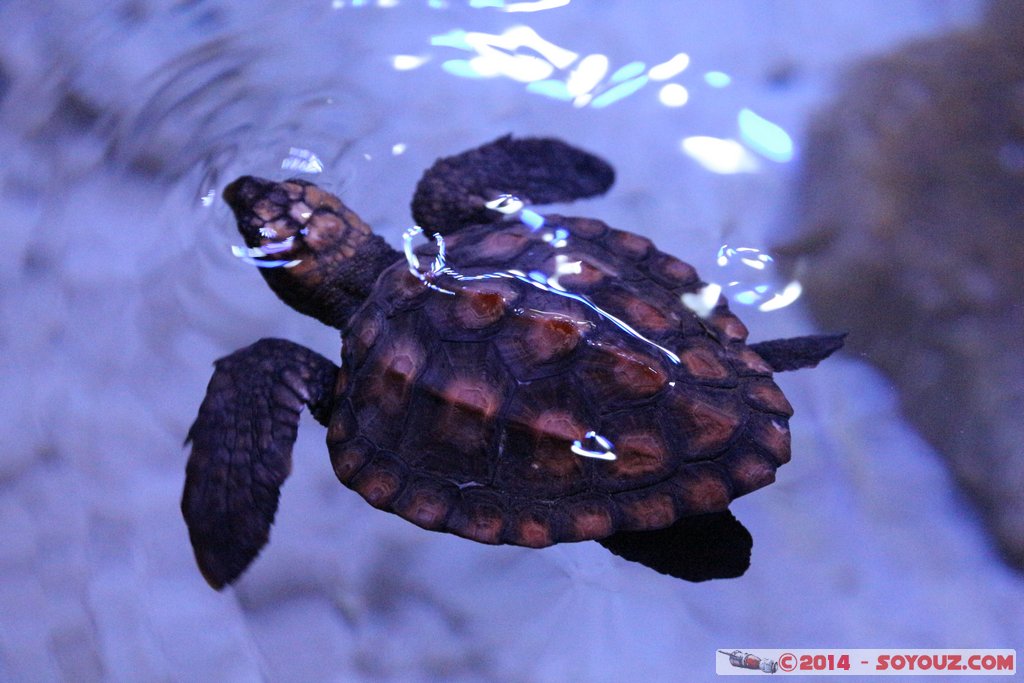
left=328, top=217, right=792, bottom=547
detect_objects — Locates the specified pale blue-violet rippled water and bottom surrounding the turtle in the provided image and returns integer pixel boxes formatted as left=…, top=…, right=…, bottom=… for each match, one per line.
left=0, top=0, right=1024, bottom=682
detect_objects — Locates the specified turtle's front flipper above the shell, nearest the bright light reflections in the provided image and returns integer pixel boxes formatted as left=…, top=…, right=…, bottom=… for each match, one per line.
left=413, top=135, right=615, bottom=234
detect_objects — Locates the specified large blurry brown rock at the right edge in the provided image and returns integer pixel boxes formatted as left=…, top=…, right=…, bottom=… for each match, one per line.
left=778, top=0, right=1024, bottom=569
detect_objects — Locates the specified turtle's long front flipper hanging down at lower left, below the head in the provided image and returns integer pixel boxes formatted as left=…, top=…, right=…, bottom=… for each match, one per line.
left=181, top=339, right=338, bottom=591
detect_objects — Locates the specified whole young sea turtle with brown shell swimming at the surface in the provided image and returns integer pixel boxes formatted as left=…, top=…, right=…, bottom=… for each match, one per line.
left=181, top=136, right=842, bottom=590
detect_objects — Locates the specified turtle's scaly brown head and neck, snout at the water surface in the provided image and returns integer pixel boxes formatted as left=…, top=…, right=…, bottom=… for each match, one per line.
left=223, top=175, right=400, bottom=328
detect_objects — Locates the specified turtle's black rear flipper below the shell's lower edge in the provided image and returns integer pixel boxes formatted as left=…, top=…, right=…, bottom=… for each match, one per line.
left=598, top=510, right=754, bottom=582
